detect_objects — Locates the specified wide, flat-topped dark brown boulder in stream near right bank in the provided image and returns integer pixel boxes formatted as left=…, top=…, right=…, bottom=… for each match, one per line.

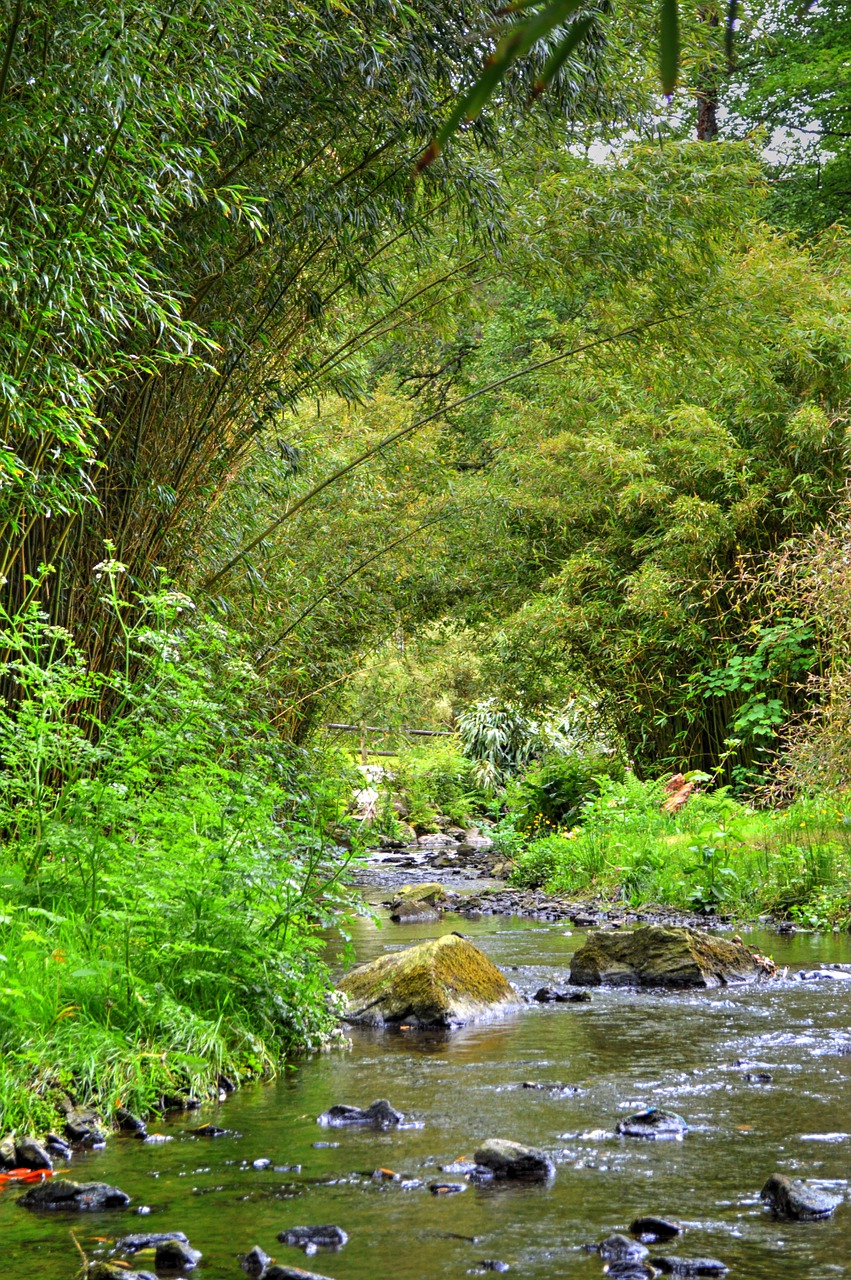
left=571, top=924, right=774, bottom=987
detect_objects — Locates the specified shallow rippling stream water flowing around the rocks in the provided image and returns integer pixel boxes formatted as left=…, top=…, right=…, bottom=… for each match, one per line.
left=0, top=916, right=851, bottom=1280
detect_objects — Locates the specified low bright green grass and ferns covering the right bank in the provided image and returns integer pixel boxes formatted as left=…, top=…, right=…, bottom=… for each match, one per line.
left=513, top=774, right=851, bottom=927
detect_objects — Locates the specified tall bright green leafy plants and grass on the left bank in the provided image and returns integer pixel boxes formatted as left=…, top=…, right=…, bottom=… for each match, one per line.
left=0, top=563, right=358, bottom=1133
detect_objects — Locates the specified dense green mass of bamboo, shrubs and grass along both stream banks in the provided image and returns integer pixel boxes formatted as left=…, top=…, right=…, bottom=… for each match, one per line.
left=0, top=0, right=851, bottom=1130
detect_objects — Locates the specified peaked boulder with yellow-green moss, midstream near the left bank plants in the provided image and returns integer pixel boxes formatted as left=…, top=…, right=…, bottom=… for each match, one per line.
left=338, top=933, right=520, bottom=1027
